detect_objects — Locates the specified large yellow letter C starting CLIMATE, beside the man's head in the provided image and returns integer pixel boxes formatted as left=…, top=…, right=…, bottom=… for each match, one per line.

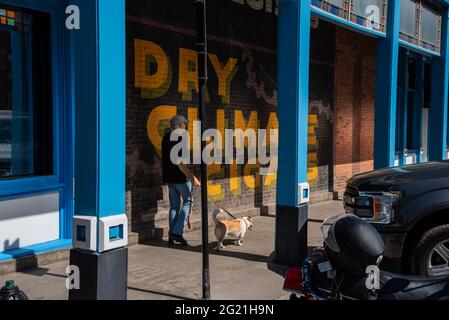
left=147, top=105, right=177, bottom=152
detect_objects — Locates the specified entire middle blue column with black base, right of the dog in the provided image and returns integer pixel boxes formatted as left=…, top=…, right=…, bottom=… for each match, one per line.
left=276, top=0, right=311, bottom=266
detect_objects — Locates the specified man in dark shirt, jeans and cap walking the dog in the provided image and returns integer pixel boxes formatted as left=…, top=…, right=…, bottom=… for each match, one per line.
left=162, top=115, right=200, bottom=246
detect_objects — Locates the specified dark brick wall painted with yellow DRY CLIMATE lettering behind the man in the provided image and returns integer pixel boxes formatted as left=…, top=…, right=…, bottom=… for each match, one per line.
left=126, top=0, right=368, bottom=240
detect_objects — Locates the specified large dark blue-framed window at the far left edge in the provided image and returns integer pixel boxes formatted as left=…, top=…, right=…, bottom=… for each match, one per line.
left=0, top=4, right=53, bottom=179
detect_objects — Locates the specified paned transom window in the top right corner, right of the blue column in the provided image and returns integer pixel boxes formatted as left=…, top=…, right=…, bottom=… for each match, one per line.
left=400, top=0, right=441, bottom=52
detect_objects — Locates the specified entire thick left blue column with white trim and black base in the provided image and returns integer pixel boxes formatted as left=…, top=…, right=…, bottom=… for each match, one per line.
left=70, top=0, right=128, bottom=300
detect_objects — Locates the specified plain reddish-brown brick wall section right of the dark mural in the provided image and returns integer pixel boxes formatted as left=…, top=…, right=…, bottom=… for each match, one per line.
left=334, top=27, right=376, bottom=192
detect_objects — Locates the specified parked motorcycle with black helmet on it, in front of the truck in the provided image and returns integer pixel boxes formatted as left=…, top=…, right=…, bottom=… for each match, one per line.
left=284, top=214, right=449, bottom=301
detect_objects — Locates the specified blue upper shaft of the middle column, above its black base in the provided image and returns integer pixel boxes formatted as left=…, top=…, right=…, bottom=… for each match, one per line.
left=277, top=0, right=311, bottom=207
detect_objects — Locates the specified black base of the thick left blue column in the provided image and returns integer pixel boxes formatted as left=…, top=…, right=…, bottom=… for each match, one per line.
left=69, top=248, right=128, bottom=301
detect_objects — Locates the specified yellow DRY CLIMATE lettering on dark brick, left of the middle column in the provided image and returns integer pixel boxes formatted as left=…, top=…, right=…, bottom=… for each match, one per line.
left=130, top=39, right=279, bottom=200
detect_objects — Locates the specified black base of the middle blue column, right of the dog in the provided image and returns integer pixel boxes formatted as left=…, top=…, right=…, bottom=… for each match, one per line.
left=275, top=205, right=309, bottom=267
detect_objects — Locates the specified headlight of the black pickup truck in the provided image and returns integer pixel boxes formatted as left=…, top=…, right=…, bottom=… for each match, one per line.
left=360, top=192, right=401, bottom=224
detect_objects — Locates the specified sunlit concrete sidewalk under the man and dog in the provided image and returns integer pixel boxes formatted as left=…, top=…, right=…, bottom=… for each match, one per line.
left=0, top=201, right=342, bottom=300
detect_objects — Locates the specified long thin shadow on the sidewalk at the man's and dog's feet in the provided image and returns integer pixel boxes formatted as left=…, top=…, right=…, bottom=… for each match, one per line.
left=141, top=240, right=270, bottom=263
